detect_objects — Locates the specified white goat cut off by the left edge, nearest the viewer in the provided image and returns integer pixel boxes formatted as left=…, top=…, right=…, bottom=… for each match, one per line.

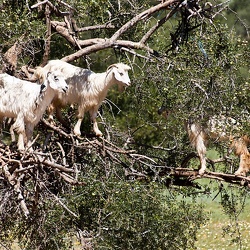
left=0, top=71, right=68, bottom=150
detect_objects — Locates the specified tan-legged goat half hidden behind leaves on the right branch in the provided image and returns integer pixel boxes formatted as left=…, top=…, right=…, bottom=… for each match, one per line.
left=158, top=106, right=250, bottom=176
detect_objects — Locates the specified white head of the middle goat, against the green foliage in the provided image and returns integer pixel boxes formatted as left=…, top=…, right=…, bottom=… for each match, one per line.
left=107, top=63, right=131, bottom=92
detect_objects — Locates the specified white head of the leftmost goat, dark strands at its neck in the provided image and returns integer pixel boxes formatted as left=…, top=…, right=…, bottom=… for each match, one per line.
left=44, top=71, right=68, bottom=93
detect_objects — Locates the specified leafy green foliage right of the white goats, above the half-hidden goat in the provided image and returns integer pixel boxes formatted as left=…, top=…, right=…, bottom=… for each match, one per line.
left=110, top=23, right=249, bottom=175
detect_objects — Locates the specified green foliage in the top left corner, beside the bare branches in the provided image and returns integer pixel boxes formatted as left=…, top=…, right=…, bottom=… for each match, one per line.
left=0, top=1, right=46, bottom=59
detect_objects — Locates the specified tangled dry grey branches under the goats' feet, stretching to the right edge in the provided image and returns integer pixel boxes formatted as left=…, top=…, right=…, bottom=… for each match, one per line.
left=0, top=114, right=250, bottom=217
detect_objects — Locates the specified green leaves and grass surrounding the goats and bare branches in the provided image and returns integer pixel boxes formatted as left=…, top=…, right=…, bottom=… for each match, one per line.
left=0, top=0, right=250, bottom=249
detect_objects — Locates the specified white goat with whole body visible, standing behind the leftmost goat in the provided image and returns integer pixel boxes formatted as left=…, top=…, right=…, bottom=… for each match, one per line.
left=41, top=60, right=130, bottom=136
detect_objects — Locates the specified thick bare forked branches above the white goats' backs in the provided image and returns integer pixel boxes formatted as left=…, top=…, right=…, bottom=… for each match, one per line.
left=26, top=0, right=227, bottom=62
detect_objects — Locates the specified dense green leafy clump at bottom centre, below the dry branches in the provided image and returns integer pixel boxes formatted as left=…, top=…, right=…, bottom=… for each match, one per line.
left=73, top=180, right=204, bottom=249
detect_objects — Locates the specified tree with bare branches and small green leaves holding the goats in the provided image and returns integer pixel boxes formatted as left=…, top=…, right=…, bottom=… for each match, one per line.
left=0, top=0, right=249, bottom=249
